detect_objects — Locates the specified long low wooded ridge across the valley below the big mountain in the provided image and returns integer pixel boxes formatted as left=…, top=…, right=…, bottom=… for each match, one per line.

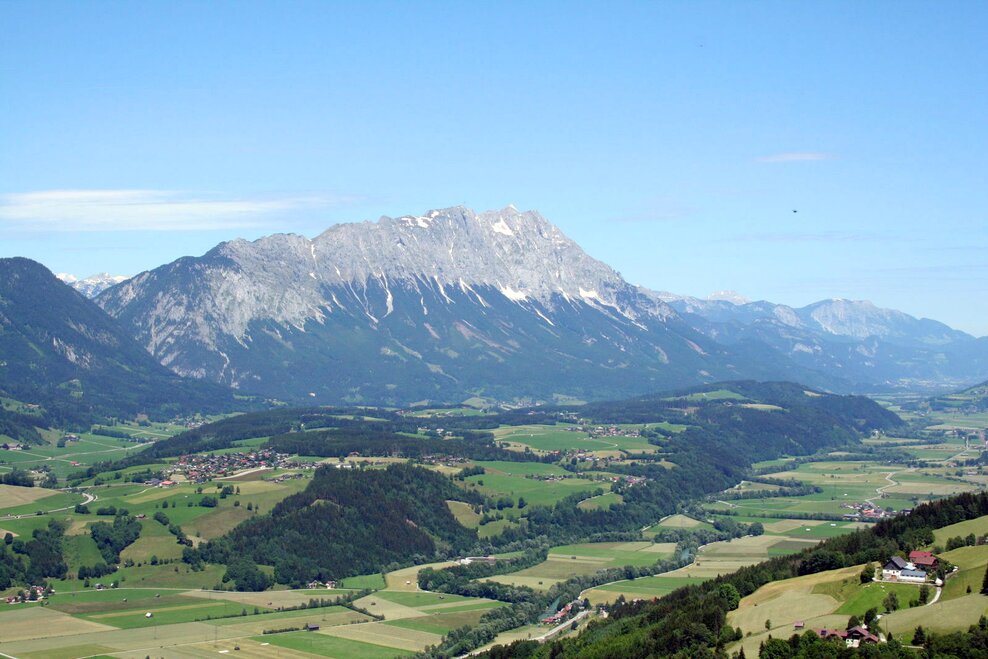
left=102, top=381, right=902, bottom=474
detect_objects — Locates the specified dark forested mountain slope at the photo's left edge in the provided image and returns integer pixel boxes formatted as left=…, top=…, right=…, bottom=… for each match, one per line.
left=0, top=258, right=238, bottom=423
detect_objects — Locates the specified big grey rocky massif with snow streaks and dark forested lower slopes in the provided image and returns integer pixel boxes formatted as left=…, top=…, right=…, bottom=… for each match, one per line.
left=98, top=207, right=756, bottom=402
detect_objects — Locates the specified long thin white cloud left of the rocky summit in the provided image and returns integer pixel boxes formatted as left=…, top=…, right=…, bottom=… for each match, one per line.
left=0, top=190, right=348, bottom=232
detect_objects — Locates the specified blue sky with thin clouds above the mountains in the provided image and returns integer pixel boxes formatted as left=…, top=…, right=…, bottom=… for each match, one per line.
left=0, top=1, right=988, bottom=335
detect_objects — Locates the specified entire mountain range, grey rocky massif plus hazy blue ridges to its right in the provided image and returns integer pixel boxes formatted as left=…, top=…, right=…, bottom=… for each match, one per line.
left=79, top=207, right=988, bottom=404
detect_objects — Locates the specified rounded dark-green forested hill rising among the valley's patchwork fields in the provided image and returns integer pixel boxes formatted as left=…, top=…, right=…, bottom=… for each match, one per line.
left=195, top=465, right=481, bottom=585
